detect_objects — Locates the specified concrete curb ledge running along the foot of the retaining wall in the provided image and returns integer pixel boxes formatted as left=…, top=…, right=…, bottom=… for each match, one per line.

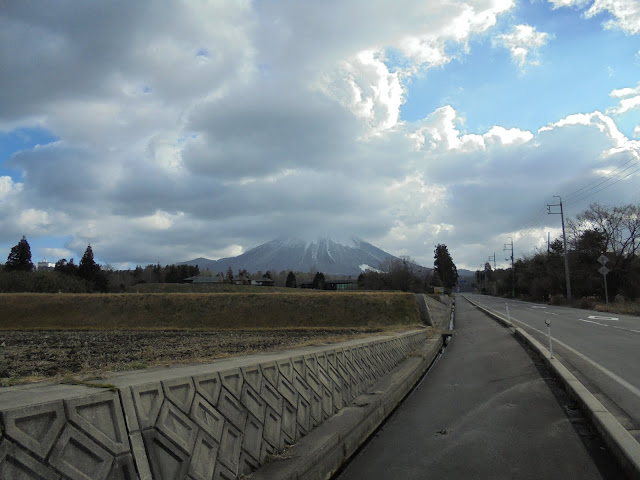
left=249, top=336, right=443, bottom=480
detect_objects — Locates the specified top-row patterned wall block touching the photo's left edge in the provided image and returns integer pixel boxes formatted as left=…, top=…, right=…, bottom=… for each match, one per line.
left=2, top=402, right=66, bottom=459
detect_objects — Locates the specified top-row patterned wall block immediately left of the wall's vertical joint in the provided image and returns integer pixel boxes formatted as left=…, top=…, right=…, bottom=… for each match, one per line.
left=64, top=392, right=131, bottom=455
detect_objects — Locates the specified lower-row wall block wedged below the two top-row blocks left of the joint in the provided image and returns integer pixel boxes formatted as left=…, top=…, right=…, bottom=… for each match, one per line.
left=49, top=424, right=113, bottom=480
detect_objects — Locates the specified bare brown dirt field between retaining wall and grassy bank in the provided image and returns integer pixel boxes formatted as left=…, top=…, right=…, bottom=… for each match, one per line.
left=0, top=329, right=430, bottom=386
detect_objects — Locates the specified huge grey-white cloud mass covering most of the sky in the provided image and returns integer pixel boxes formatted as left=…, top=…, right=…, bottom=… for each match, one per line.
left=0, top=0, right=633, bottom=266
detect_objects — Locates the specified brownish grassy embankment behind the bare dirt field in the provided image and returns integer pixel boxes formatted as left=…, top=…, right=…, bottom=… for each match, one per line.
left=0, top=285, right=421, bottom=330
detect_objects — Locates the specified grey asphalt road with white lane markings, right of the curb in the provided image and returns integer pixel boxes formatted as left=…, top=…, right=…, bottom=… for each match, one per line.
left=466, top=295, right=640, bottom=441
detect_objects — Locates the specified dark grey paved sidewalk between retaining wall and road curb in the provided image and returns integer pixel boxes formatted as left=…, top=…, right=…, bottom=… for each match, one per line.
left=337, top=298, right=624, bottom=480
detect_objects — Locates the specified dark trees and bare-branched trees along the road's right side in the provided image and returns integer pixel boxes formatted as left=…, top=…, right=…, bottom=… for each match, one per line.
left=476, top=203, right=640, bottom=301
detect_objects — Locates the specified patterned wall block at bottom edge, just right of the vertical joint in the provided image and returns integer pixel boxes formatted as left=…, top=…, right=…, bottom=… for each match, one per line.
left=142, top=430, right=189, bottom=480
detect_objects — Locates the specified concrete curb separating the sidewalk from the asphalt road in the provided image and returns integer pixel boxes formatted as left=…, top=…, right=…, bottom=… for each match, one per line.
left=463, top=296, right=640, bottom=479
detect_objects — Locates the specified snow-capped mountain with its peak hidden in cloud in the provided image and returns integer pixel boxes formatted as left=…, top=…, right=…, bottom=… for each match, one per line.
left=182, top=237, right=404, bottom=275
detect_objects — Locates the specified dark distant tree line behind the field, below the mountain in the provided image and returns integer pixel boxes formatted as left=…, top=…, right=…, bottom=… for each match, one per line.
left=0, top=236, right=458, bottom=293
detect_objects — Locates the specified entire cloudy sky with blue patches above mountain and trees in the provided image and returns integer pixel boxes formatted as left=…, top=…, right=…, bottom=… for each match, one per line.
left=0, top=0, right=640, bottom=270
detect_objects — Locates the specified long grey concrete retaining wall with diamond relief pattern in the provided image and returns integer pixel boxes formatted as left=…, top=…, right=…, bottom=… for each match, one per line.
left=0, top=330, right=427, bottom=480
